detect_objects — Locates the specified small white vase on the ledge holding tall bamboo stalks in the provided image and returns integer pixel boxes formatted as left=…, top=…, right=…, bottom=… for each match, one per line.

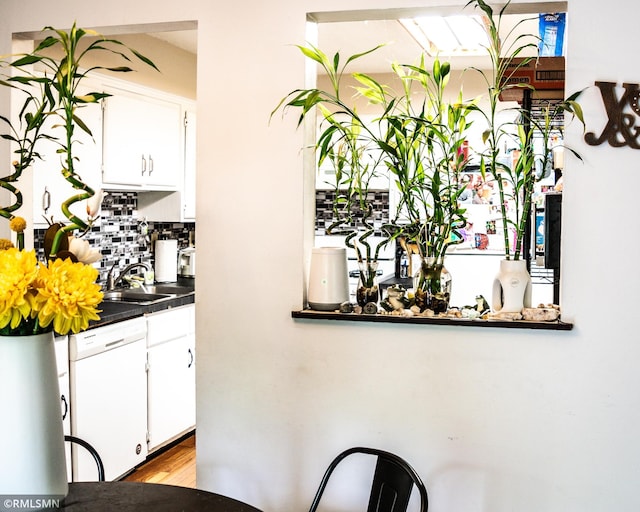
left=491, top=260, right=531, bottom=313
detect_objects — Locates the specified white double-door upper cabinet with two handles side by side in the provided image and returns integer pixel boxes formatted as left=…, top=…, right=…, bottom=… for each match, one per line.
left=102, top=88, right=184, bottom=190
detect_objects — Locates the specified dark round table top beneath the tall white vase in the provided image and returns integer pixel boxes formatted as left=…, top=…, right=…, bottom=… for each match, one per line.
left=57, top=482, right=260, bottom=512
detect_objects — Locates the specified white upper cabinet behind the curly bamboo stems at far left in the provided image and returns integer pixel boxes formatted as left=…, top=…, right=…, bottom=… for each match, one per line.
left=32, top=82, right=102, bottom=227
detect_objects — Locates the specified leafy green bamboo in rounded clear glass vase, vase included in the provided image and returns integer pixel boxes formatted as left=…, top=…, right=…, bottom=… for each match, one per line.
left=361, top=57, right=470, bottom=313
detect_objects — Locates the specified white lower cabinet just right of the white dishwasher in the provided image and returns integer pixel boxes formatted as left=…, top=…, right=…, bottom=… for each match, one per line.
left=147, top=304, right=195, bottom=452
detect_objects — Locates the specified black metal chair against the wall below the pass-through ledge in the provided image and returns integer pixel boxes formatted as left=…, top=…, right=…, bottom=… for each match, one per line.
left=309, top=447, right=429, bottom=512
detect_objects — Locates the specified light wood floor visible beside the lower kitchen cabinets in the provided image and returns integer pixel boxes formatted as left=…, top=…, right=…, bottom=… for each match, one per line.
left=124, top=434, right=196, bottom=488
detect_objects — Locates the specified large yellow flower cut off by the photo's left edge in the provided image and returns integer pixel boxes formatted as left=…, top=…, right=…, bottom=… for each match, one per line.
left=0, top=248, right=38, bottom=329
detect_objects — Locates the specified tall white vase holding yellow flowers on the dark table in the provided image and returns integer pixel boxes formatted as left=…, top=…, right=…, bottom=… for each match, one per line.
left=0, top=332, right=68, bottom=499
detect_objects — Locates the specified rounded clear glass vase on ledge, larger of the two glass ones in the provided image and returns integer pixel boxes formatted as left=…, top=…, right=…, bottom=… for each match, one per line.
left=413, top=257, right=451, bottom=313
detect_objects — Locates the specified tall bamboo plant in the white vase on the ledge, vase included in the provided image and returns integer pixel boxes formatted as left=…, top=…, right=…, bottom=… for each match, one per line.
left=467, top=0, right=584, bottom=313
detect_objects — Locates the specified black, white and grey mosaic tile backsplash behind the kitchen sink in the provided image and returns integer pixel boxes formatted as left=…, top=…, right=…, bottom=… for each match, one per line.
left=34, top=191, right=195, bottom=281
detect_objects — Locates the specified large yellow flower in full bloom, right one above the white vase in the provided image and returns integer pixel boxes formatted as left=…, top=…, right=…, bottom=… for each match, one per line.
left=36, top=259, right=102, bottom=334
